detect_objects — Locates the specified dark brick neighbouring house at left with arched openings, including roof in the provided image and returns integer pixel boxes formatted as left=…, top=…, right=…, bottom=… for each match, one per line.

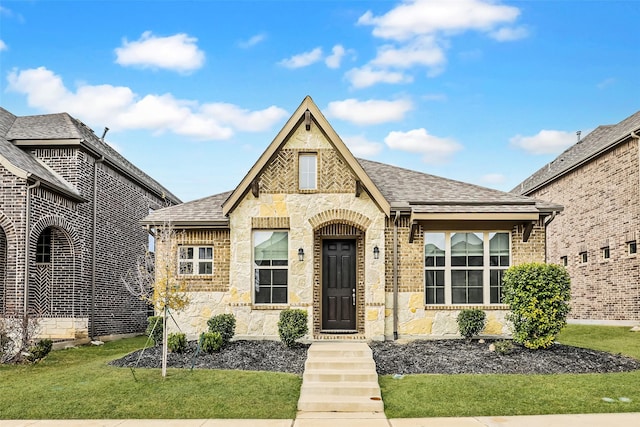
left=0, top=108, right=180, bottom=339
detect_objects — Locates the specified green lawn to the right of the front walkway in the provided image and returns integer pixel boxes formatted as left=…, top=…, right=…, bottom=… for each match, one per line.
left=380, top=325, right=640, bottom=418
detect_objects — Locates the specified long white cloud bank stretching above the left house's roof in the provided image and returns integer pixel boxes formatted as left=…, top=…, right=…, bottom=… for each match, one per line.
left=8, top=67, right=288, bottom=139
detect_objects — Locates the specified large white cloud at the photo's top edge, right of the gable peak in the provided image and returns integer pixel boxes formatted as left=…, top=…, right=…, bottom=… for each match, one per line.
left=358, top=0, right=520, bottom=40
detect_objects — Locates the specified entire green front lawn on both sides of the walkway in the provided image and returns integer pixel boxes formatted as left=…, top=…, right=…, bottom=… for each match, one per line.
left=0, top=325, right=640, bottom=419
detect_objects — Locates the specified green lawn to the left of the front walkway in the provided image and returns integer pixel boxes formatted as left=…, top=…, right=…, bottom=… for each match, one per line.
left=0, top=338, right=302, bottom=419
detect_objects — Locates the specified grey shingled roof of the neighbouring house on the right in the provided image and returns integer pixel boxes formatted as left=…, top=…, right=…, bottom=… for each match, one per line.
left=511, top=111, right=640, bottom=195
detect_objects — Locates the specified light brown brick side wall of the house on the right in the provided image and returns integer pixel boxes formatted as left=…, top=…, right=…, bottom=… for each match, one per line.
left=531, top=139, right=640, bottom=320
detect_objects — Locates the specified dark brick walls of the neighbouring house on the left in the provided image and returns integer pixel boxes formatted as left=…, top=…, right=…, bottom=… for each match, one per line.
left=0, top=147, right=170, bottom=336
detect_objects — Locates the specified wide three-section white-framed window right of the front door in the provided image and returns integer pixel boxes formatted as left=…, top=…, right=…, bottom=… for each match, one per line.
left=424, top=232, right=511, bottom=305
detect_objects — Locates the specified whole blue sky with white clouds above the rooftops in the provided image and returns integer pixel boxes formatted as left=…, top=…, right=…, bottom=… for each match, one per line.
left=0, top=0, right=640, bottom=201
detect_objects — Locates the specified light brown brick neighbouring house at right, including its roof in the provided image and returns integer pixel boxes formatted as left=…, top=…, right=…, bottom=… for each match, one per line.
left=512, top=111, right=640, bottom=324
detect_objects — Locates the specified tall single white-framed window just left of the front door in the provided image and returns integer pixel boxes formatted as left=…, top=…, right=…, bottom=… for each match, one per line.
left=253, top=230, right=289, bottom=304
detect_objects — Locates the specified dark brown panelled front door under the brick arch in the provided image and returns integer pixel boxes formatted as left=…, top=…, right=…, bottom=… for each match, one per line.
left=322, top=240, right=356, bottom=331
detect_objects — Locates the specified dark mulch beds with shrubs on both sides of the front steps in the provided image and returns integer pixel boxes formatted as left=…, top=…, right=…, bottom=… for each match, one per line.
left=111, top=339, right=640, bottom=375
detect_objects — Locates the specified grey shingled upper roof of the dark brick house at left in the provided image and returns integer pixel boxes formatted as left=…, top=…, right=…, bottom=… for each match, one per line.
left=0, top=107, right=180, bottom=203
